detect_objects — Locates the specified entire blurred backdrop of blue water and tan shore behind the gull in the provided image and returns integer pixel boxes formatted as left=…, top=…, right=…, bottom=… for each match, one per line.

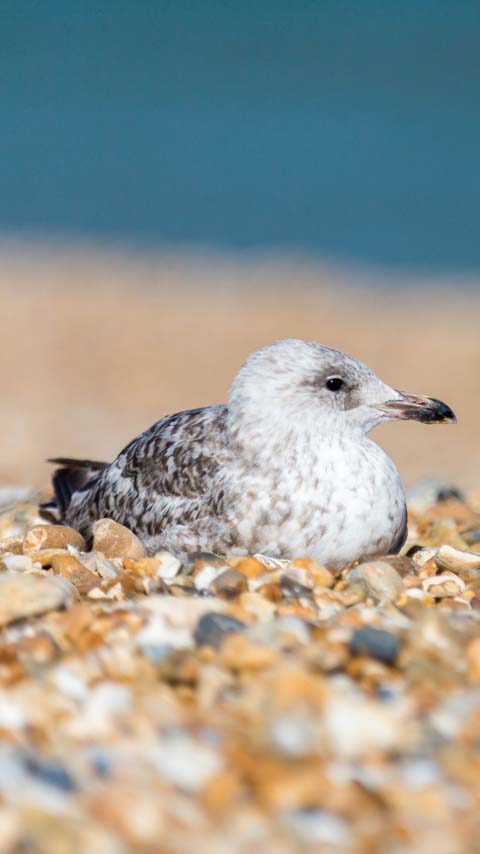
left=0, top=0, right=480, bottom=486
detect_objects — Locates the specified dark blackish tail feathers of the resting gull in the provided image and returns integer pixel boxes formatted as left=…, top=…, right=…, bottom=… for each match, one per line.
left=39, top=457, right=109, bottom=522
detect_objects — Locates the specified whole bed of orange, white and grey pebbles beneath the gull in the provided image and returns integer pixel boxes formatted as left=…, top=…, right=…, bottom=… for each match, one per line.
left=0, top=492, right=480, bottom=854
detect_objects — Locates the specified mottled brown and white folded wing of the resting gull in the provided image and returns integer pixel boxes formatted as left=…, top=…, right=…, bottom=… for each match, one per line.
left=66, top=406, right=227, bottom=535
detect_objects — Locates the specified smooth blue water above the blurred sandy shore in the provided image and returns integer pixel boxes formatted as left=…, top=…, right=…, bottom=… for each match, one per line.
left=0, top=0, right=480, bottom=271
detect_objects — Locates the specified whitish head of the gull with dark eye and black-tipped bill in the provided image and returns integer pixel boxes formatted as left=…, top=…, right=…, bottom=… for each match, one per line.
left=230, top=339, right=456, bottom=433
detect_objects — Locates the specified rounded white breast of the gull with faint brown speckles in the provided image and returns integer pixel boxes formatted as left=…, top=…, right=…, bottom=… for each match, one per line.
left=228, top=437, right=405, bottom=567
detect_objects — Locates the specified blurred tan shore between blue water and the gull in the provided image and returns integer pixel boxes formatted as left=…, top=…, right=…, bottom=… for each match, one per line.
left=0, top=245, right=480, bottom=487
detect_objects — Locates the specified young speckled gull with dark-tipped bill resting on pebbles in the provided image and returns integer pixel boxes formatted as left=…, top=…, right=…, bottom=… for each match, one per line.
left=47, top=339, right=455, bottom=567
